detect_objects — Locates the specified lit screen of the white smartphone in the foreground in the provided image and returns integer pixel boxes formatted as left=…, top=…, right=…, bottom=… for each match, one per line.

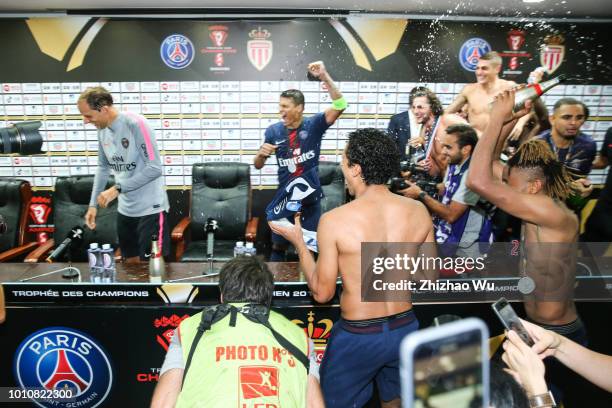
left=412, top=326, right=483, bottom=408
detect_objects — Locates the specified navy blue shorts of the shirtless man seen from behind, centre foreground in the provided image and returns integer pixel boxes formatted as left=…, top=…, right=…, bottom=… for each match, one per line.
left=319, top=310, right=419, bottom=408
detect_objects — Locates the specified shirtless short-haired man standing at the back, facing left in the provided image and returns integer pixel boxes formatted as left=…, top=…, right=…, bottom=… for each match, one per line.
left=444, top=51, right=516, bottom=136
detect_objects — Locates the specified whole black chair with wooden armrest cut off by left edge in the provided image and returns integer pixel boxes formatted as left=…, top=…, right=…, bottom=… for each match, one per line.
left=0, top=178, right=38, bottom=262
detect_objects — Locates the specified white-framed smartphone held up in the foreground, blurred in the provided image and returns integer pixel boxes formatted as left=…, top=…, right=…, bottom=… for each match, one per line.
left=400, top=318, right=489, bottom=408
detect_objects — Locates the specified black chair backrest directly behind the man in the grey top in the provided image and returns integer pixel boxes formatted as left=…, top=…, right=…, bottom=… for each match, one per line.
left=53, top=176, right=119, bottom=262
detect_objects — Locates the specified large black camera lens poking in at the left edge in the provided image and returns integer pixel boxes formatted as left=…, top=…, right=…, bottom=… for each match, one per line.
left=0, top=121, right=43, bottom=156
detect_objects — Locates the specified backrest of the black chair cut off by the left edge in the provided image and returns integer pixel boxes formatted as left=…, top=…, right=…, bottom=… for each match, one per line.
left=0, top=178, right=32, bottom=252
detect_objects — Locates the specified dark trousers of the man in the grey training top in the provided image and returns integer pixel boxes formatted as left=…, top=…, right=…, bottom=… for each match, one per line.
left=117, top=211, right=170, bottom=261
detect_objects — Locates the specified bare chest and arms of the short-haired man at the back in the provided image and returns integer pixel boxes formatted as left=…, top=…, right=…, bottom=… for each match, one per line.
left=458, top=78, right=516, bottom=133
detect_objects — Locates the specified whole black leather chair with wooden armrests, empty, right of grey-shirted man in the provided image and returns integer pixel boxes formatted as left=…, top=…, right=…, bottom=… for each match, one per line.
left=172, top=163, right=258, bottom=262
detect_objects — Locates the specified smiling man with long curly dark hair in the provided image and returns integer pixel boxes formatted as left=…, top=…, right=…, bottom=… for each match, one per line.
left=409, top=88, right=467, bottom=177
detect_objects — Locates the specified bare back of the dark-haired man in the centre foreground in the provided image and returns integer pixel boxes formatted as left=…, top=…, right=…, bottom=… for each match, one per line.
left=318, top=186, right=433, bottom=320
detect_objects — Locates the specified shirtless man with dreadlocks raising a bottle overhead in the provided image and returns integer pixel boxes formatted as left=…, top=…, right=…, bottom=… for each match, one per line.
left=467, top=90, right=586, bottom=401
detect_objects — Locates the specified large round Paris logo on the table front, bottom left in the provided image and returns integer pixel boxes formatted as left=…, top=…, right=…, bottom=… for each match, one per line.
left=13, top=327, right=113, bottom=408
